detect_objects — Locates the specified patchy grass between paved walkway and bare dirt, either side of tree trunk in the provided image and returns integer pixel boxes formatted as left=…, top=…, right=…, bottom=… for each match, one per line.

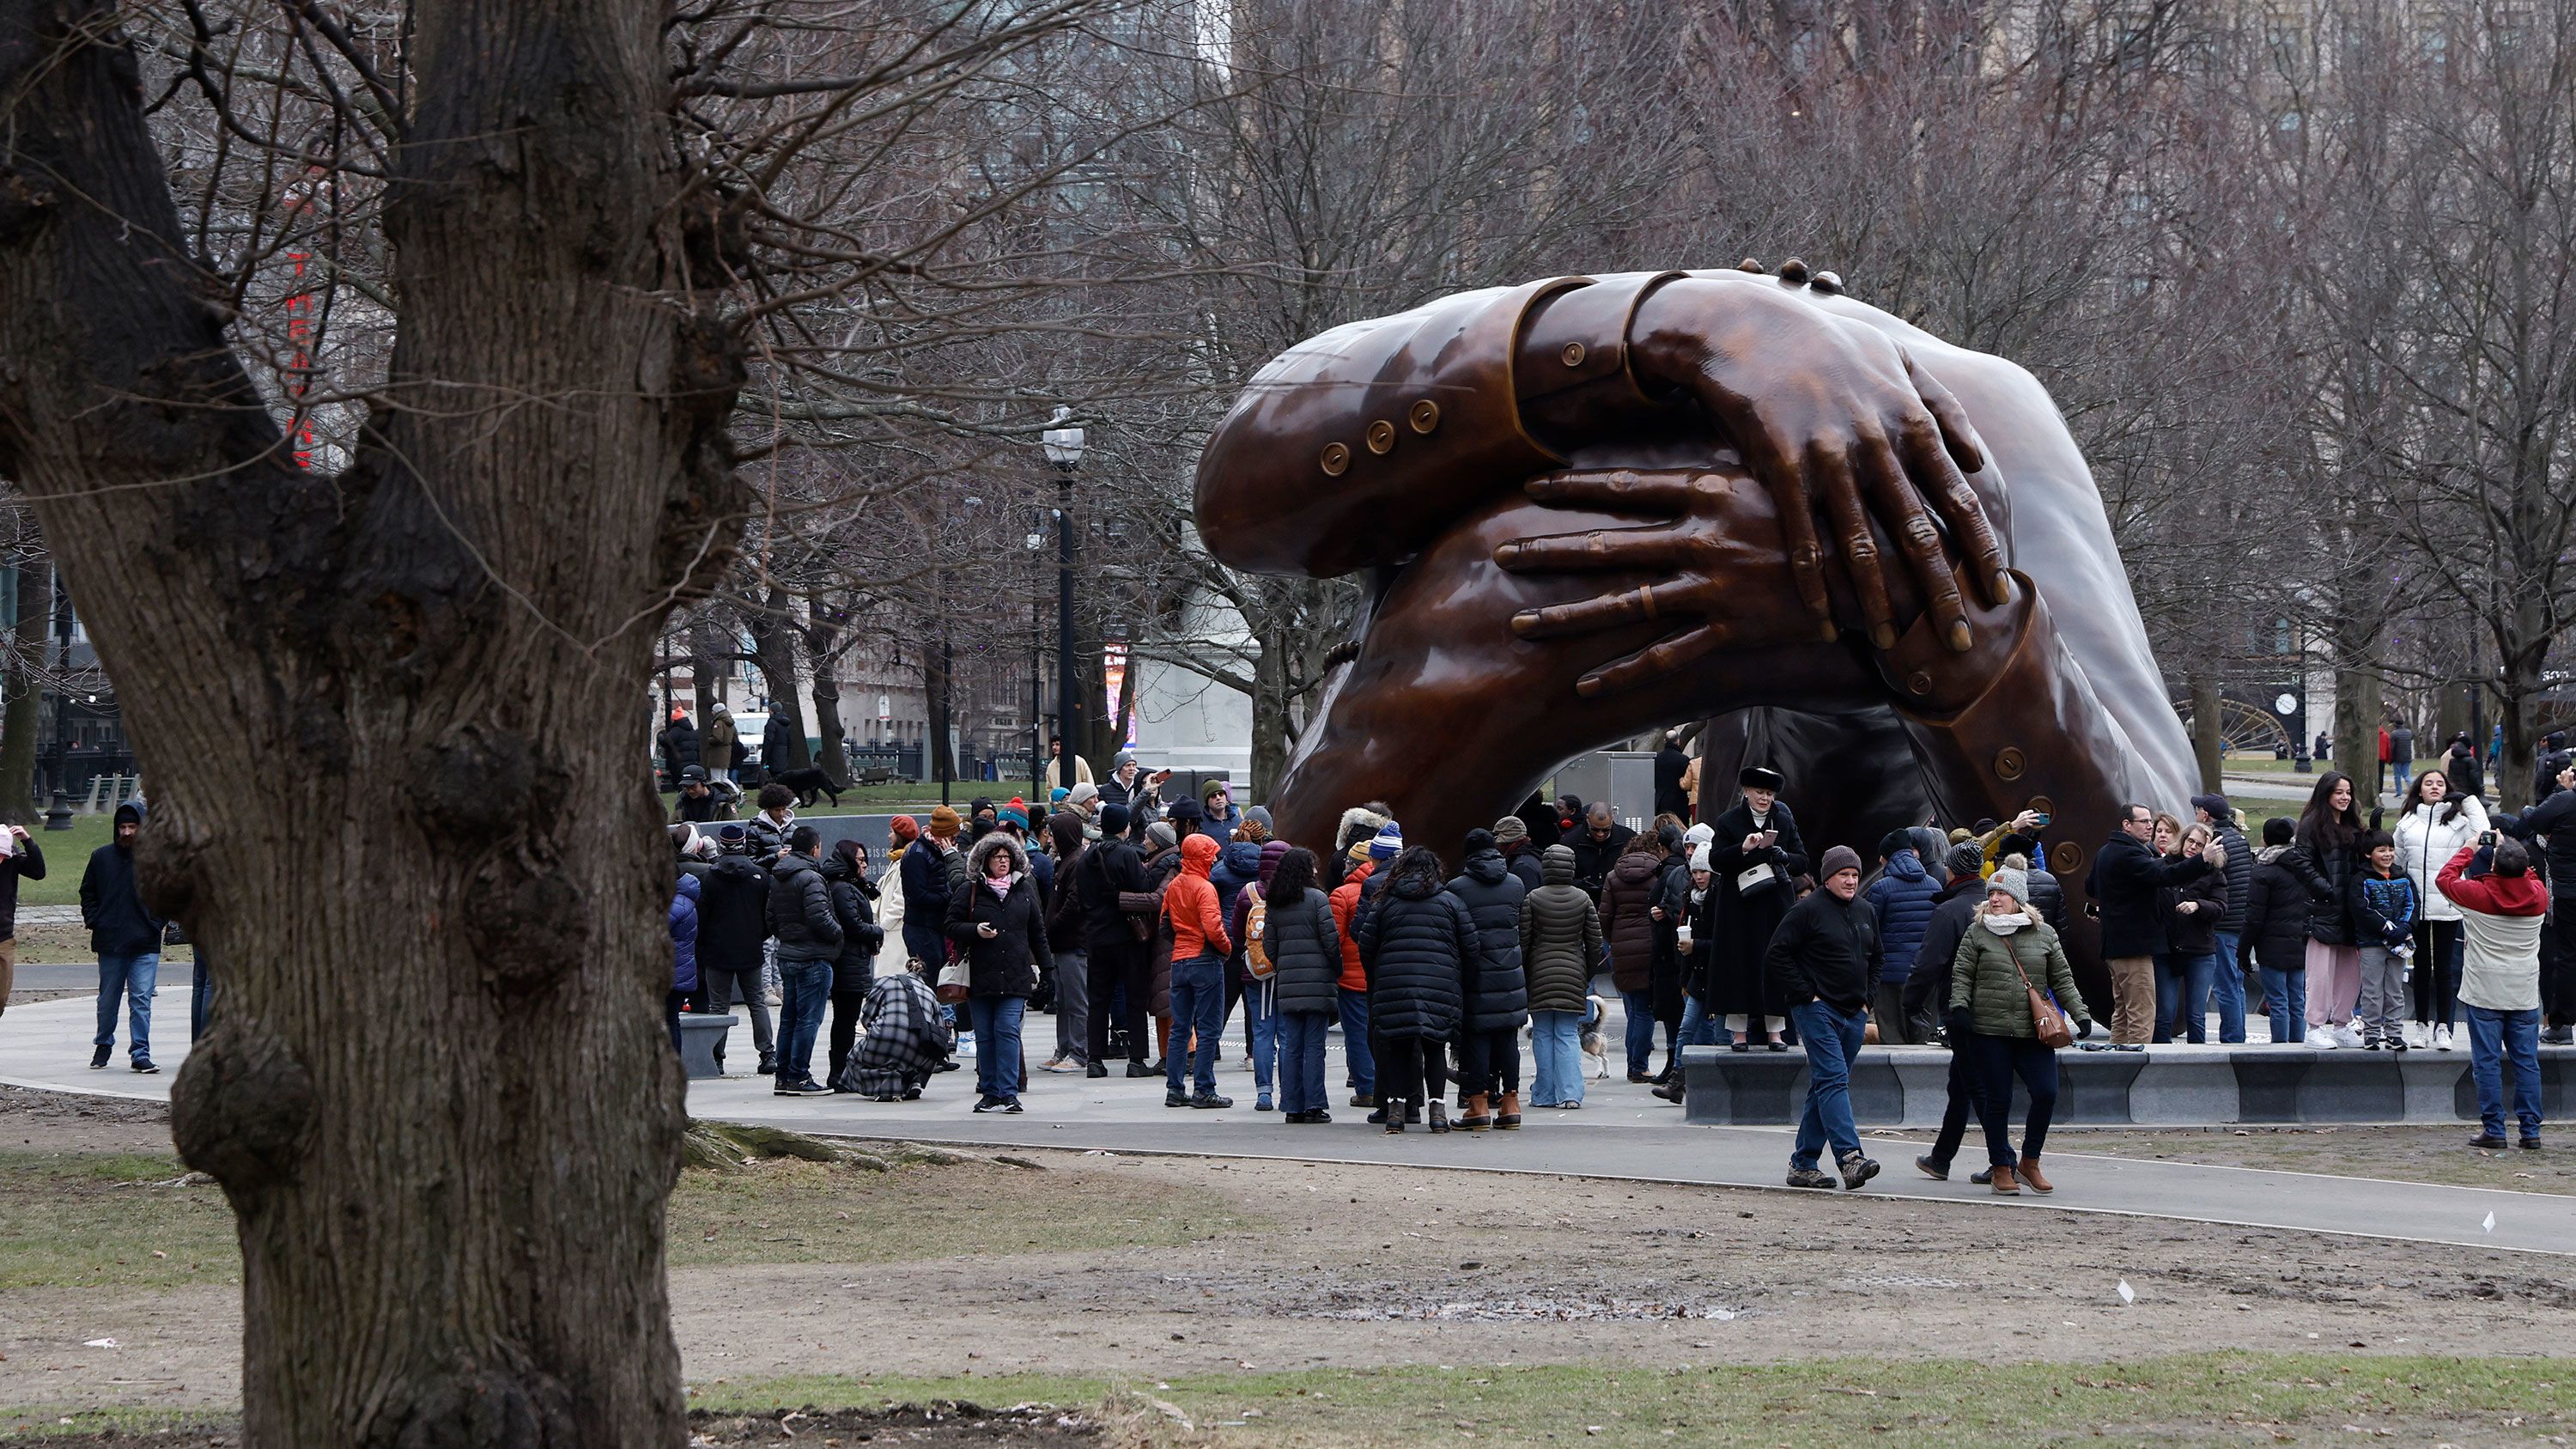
left=0, top=1153, right=1255, bottom=1289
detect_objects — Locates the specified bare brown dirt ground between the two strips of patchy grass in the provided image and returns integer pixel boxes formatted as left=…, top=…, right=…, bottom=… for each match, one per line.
left=0, top=1114, right=2576, bottom=1405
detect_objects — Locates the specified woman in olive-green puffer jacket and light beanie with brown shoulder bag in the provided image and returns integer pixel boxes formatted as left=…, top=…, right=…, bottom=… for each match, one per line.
left=1950, top=856, right=2092, bottom=1196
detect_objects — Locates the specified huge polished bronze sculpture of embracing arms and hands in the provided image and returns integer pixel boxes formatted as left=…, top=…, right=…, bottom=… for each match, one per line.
left=1198, top=263, right=2195, bottom=990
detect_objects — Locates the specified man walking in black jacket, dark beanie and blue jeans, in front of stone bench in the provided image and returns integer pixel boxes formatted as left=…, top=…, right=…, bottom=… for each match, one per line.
left=1762, top=846, right=1880, bottom=1189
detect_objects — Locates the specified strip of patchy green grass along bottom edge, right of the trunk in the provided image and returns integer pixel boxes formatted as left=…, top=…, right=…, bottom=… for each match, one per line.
left=690, top=1354, right=2576, bottom=1446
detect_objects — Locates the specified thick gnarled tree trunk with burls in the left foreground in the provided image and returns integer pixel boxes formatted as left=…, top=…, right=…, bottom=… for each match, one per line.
left=0, top=0, right=739, bottom=1446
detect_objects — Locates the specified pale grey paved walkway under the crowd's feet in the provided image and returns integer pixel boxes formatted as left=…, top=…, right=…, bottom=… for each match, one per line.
left=0, top=990, right=2576, bottom=1253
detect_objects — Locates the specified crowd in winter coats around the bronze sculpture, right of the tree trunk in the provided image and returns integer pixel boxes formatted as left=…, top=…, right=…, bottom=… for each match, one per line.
left=672, top=732, right=2576, bottom=1175
